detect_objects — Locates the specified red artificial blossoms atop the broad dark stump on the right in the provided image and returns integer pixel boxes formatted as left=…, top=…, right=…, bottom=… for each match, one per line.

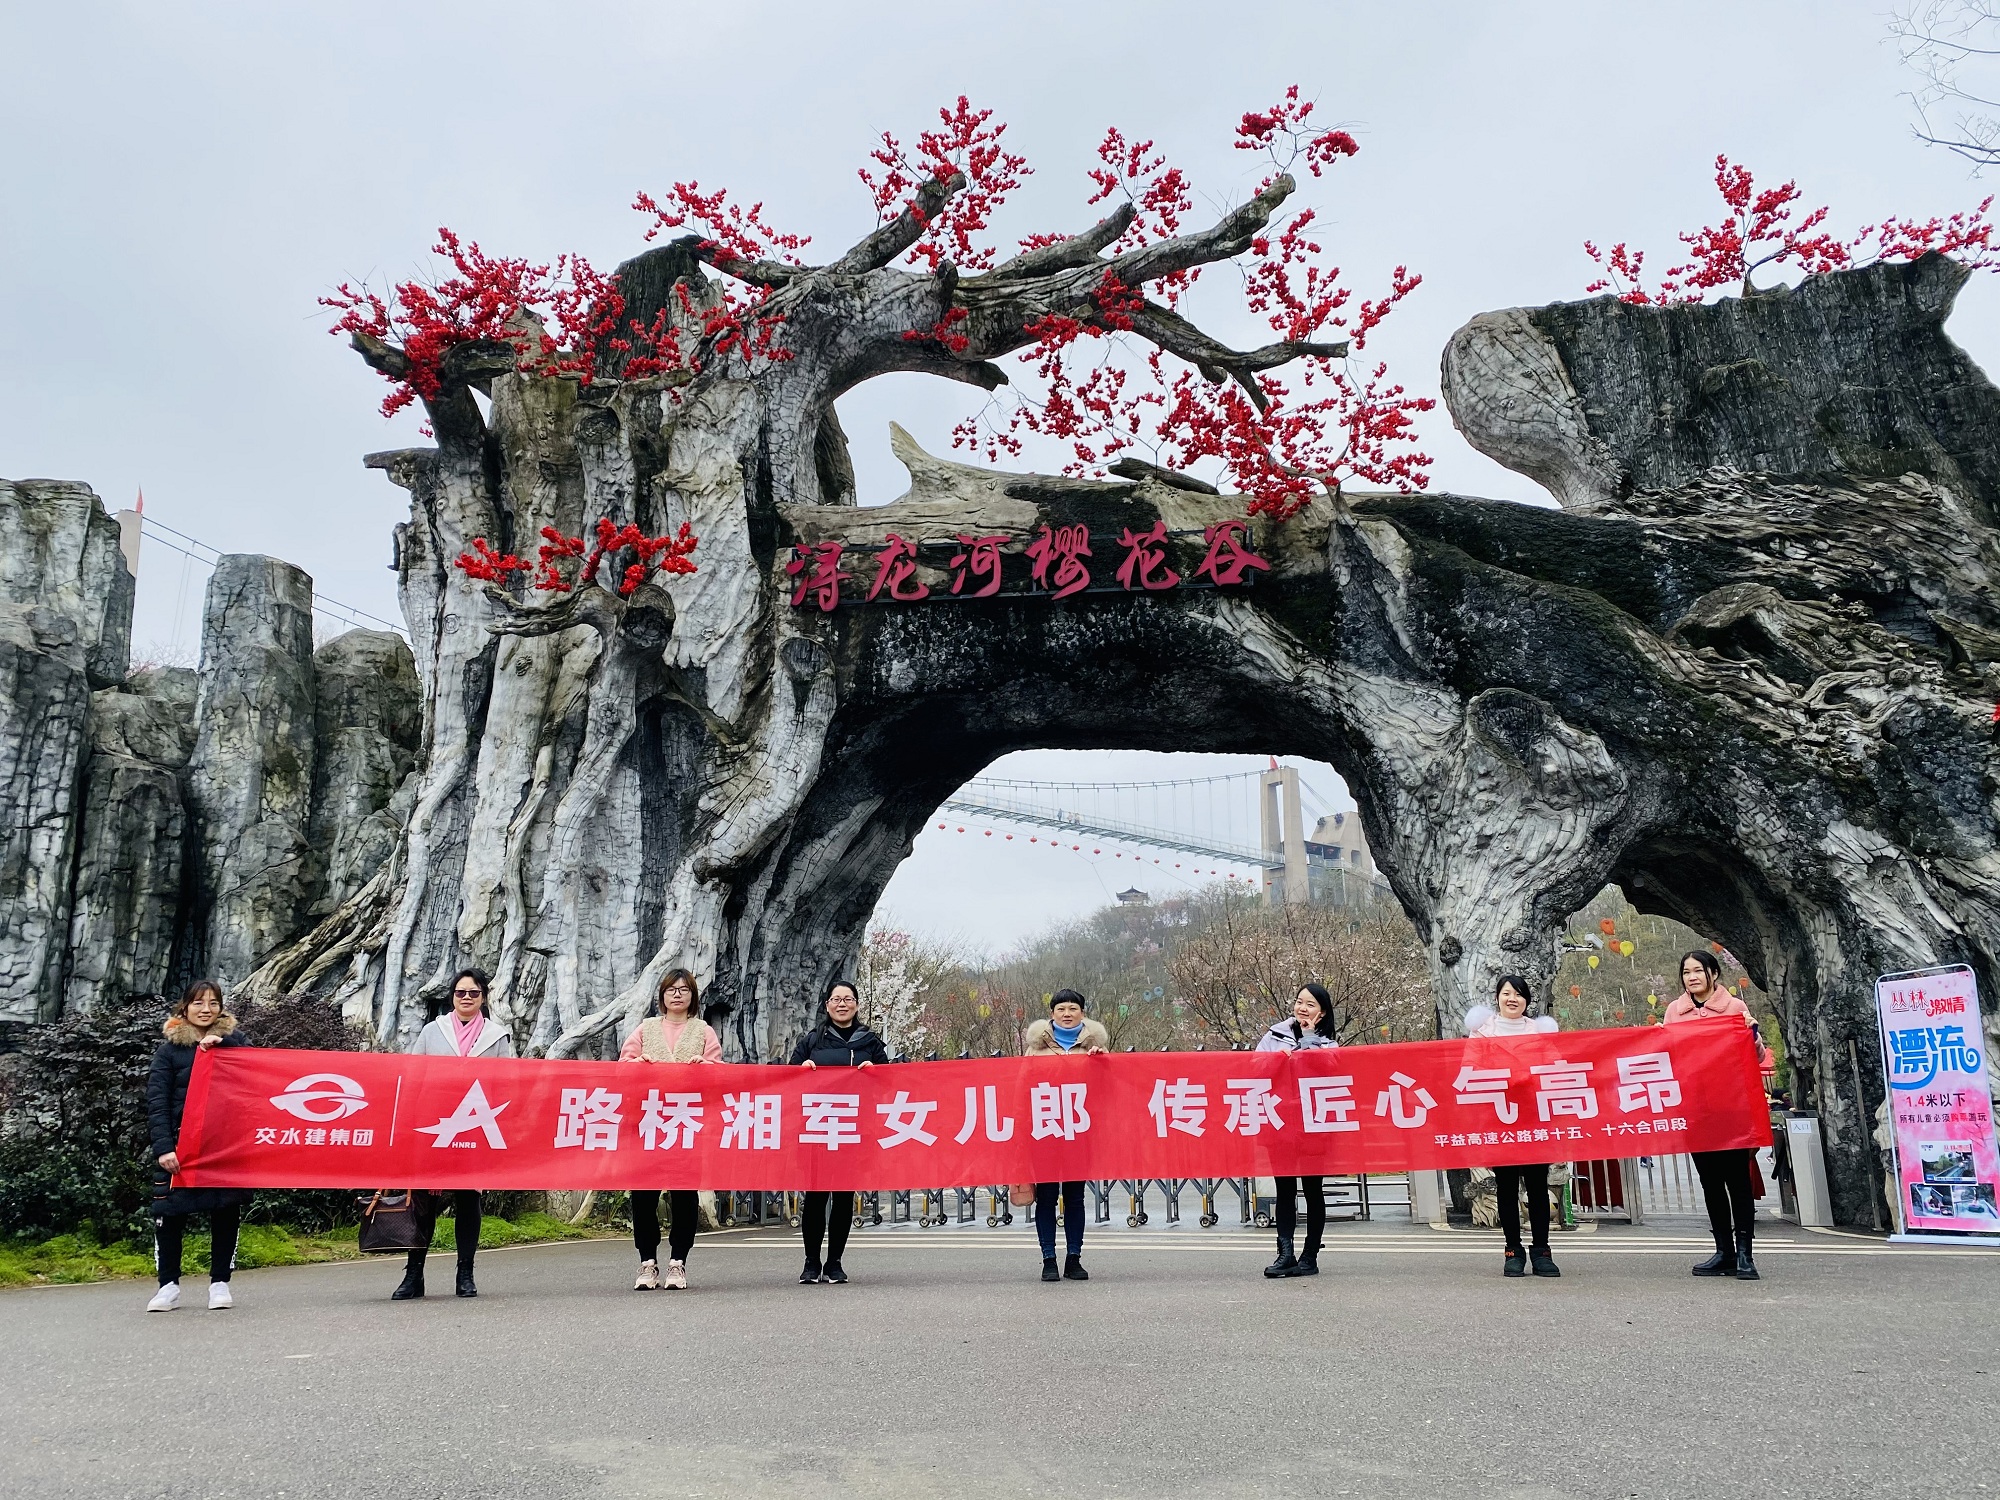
left=1584, top=156, right=2000, bottom=306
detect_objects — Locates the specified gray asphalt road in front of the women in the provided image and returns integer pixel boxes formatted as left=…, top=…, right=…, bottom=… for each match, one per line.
left=0, top=1224, right=2000, bottom=1500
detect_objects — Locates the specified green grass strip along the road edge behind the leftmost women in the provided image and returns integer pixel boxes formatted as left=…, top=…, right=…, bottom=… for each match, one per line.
left=0, top=1212, right=602, bottom=1288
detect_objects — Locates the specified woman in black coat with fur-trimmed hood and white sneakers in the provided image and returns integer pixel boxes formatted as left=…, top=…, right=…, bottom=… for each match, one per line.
left=146, top=980, right=250, bottom=1312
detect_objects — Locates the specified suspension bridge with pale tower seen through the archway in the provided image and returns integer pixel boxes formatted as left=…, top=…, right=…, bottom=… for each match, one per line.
left=938, top=760, right=1388, bottom=904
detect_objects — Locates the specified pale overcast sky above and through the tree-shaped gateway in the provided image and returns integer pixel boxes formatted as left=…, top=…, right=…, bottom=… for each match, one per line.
left=0, top=0, right=2000, bottom=946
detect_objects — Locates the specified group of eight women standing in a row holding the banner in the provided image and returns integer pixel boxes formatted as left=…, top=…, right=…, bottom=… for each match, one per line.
left=146, top=950, right=1770, bottom=1312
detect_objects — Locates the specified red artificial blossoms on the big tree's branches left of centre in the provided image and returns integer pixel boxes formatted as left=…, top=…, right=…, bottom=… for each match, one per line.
left=344, top=86, right=1440, bottom=524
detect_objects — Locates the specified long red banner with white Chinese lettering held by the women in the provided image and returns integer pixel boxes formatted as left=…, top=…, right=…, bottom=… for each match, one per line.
left=176, top=1026, right=1770, bottom=1190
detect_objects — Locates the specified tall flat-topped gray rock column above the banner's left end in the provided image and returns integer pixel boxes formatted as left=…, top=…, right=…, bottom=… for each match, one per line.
left=188, top=554, right=318, bottom=986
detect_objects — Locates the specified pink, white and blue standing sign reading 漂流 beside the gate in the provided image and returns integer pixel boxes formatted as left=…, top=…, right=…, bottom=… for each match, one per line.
left=1876, top=966, right=2000, bottom=1234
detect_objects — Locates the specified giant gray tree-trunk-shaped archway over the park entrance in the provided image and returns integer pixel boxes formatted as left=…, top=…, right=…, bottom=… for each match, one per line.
left=250, top=147, right=2000, bottom=1222
